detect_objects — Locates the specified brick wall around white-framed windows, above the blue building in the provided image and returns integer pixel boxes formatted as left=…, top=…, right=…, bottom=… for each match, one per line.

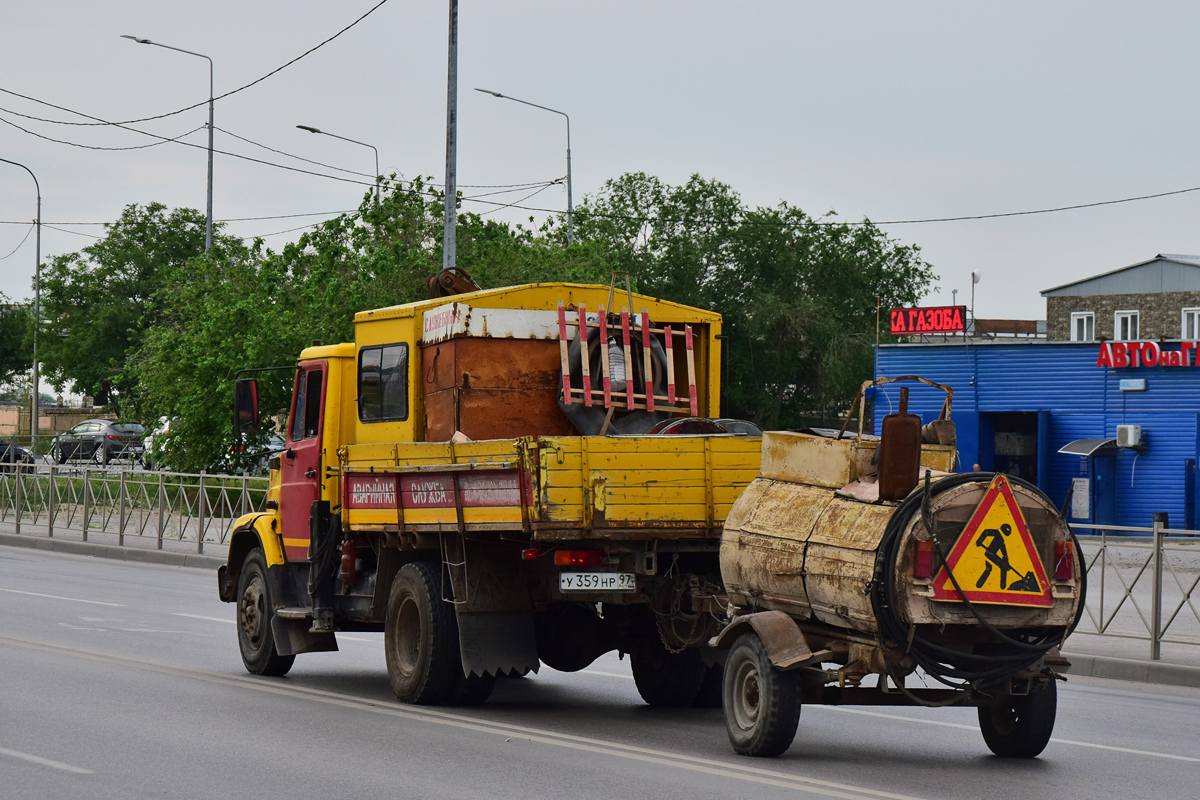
left=1046, top=291, right=1200, bottom=342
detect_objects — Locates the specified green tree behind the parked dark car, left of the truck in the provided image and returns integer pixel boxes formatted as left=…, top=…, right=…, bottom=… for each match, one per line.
left=38, top=203, right=238, bottom=410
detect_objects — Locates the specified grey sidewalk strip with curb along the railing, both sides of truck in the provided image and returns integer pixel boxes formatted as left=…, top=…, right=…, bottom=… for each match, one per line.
left=0, top=524, right=1200, bottom=688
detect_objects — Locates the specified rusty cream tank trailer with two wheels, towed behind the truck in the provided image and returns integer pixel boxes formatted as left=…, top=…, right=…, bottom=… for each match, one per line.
left=712, top=379, right=1086, bottom=757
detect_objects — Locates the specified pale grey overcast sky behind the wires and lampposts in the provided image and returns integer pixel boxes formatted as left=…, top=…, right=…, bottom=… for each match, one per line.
left=0, top=0, right=1200, bottom=318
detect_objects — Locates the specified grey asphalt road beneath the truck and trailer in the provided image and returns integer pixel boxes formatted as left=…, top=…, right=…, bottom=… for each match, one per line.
left=0, top=547, right=1200, bottom=800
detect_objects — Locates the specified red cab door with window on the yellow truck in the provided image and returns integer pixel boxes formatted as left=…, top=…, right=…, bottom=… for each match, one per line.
left=280, top=361, right=329, bottom=561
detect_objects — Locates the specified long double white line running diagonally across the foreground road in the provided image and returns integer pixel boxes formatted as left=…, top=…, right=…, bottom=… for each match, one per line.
left=0, top=634, right=919, bottom=800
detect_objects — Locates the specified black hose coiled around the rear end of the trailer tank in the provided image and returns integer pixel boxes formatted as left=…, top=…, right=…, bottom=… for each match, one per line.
left=871, top=473, right=1087, bottom=690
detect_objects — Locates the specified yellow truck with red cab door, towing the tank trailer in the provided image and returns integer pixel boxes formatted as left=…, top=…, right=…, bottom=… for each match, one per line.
left=218, top=283, right=761, bottom=705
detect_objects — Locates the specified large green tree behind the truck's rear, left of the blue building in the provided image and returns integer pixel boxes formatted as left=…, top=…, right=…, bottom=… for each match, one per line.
left=577, top=173, right=934, bottom=428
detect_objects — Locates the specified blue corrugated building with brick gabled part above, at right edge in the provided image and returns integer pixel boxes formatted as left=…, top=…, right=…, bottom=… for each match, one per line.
left=874, top=255, right=1200, bottom=530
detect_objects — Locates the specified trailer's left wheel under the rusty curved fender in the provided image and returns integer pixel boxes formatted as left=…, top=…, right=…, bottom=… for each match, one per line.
left=722, top=632, right=800, bottom=757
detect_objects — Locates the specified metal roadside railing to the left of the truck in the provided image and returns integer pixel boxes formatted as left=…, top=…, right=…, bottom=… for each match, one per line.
left=0, top=465, right=268, bottom=553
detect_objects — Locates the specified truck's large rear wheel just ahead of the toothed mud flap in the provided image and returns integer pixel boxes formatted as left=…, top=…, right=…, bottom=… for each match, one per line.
left=384, top=563, right=466, bottom=705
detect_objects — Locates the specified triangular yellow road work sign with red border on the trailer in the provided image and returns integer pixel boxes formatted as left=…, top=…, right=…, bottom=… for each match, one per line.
left=934, top=475, right=1054, bottom=607
